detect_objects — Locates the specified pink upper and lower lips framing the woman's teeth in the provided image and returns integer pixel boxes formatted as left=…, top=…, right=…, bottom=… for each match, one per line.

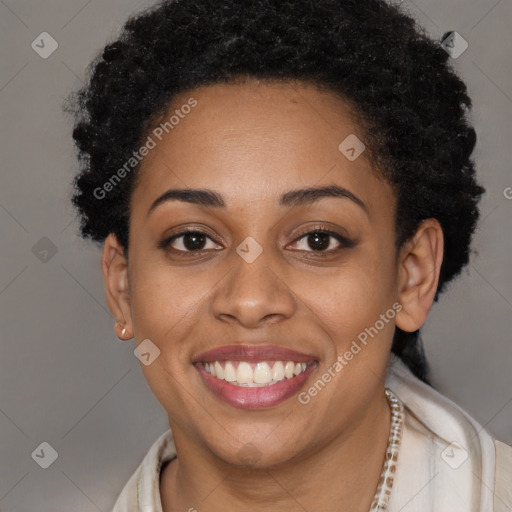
left=193, top=345, right=318, bottom=409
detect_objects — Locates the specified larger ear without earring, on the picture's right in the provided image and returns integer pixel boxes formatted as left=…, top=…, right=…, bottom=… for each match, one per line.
left=396, top=219, right=444, bottom=332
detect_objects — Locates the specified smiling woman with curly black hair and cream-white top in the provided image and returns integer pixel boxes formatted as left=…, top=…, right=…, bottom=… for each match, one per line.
left=66, top=0, right=512, bottom=512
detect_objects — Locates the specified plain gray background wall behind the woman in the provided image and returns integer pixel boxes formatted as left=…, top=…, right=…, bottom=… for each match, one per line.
left=0, top=0, right=512, bottom=512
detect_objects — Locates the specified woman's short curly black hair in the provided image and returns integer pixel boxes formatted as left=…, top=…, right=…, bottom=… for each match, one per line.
left=65, top=0, right=484, bottom=382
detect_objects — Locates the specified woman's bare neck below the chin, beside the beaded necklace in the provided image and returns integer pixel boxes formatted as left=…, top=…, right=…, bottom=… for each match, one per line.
left=160, top=388, right=390, bottom=512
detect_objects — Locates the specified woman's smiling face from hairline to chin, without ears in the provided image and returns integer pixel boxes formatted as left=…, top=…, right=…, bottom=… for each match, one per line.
left=104, top=81, right=440, bottom=467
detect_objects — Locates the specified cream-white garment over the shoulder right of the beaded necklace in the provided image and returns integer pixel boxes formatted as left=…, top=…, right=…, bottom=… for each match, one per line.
left=386, top=356, right=512, bottom=512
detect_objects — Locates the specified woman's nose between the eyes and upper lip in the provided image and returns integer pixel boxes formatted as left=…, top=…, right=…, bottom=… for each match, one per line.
left=212, top=250, right=297, bottom=329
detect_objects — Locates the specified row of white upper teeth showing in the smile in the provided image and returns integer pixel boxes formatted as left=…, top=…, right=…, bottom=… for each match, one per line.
left=203, top=361, right=308, bottom=387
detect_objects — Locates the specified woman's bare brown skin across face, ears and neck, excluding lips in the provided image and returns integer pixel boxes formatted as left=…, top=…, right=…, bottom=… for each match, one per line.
left=102, top=79, right=443, bottom=512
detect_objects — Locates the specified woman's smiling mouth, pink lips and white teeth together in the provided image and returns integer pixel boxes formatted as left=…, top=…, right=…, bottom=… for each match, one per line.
left=194, top=345, right=318, bottom=409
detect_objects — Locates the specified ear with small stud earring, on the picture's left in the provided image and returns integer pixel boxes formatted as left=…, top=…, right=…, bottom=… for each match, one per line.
left=101, top=233, right=133, bottom=340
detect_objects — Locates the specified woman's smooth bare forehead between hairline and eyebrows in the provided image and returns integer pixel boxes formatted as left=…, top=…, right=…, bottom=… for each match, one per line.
left=134, top=80, right=388, bottom=214
